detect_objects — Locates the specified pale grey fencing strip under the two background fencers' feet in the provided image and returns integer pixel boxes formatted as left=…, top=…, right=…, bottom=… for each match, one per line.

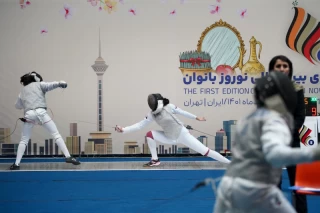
left=0, top=161, right=226, bottom=172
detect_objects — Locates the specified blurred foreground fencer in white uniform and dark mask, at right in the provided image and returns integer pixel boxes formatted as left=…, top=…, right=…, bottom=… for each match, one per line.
left=214, top=72, right=320, bottom=213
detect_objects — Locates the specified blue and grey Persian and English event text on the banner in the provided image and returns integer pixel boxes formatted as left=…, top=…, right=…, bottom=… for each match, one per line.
left=183, top=72, right=320, bottom=107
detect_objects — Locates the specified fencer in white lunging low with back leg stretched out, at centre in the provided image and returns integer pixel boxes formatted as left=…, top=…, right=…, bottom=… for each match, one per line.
left=116, top=94, right=230, bottom=166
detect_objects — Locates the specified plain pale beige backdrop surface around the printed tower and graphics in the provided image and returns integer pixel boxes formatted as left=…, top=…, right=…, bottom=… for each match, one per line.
left=0, top=0, right=320, bottom=153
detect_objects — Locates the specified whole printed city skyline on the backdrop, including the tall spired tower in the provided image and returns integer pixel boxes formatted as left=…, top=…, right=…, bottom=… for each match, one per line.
left=0, top=28, right=236, bottom=155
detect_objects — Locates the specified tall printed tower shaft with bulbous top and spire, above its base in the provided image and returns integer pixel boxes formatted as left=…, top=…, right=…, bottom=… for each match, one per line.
left=91, top=28, right=109, bottom=131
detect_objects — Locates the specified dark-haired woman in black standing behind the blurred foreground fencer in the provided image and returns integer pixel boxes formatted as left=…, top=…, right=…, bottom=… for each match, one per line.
left=269, top=55, right=308, bottom=213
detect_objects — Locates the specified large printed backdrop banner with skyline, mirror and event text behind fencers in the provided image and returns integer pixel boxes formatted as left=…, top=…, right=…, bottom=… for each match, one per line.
left=0, top=0, right=320, bottom=154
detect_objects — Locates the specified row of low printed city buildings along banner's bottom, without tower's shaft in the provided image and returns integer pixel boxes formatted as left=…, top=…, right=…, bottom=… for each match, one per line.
left=0, top=120, right=237, bottom=156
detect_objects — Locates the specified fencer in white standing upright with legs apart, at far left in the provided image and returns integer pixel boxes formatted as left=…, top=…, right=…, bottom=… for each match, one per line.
left=10, top=72, right=80, bottom=170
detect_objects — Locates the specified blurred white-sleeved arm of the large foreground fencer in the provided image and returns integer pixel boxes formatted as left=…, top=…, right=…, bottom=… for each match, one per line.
left=261, top=117, right=319, bottom=168
